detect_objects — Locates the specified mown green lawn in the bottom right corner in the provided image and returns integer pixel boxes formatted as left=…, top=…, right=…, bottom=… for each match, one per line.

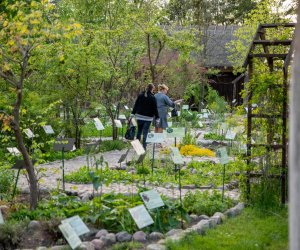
left=167, top=208, right=288, bottom=250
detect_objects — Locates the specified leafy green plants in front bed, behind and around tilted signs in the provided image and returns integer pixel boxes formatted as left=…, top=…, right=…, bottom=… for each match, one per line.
left=9, top=193, right=187, bottom=234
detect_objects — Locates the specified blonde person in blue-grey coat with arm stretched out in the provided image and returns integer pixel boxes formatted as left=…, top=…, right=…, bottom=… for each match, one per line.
left=155, top=84, right=182, bottom=133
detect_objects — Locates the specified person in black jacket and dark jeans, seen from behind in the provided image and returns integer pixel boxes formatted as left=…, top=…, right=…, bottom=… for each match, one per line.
left=131, top=83, right=159, bottom=150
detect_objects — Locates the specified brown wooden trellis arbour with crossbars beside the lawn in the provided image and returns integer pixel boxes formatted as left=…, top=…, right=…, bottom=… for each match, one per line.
left=244, top=23, right=295, bottom=204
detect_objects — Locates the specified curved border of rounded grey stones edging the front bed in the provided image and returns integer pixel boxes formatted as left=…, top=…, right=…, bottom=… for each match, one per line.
left=21, top=203, right=245, bottom=250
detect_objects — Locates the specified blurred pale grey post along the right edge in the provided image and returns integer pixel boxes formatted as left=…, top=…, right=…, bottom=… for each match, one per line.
left=289, top=3, right=300, bottom=250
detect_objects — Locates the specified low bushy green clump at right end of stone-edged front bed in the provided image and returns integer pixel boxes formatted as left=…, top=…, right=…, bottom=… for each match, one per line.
left=183, top=190, right=234, bottom=216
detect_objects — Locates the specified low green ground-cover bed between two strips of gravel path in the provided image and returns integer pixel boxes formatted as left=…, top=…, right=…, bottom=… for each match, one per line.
left=65, top=159, right=245, bottom=187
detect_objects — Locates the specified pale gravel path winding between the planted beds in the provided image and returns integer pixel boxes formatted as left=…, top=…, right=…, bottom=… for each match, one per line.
left=18, top=134, right=239, bottom=199
